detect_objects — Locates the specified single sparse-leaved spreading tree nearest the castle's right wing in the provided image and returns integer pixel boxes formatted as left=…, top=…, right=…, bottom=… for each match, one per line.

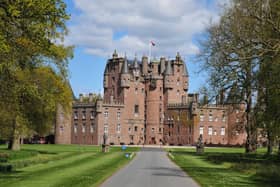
left=199, top=0, right=280, bottom=152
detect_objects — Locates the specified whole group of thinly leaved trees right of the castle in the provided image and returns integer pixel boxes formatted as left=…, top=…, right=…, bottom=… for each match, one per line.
left=198, top=0, right=280, bottom=154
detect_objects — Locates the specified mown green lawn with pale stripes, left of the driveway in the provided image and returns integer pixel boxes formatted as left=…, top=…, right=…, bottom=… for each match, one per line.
left=0, top=145, right=138, bottom=187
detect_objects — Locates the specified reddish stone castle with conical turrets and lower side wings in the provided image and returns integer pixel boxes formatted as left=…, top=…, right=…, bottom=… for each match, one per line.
left=55, top=51, right=246, bottom=145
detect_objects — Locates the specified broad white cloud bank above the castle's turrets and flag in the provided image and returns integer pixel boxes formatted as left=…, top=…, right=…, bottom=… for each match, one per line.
left=66, top=0, right=223, bottom=57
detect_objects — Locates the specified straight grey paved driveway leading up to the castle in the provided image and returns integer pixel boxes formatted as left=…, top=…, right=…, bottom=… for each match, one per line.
left=101, top=148, right=198, bottom=187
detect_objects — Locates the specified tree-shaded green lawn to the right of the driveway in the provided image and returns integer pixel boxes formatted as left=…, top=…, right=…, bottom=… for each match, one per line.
left=169, top=148, right=280, bottom=187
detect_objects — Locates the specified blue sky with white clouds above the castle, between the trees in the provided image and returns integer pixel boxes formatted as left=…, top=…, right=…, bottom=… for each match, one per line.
left=64, top=0, right=226, bottom=96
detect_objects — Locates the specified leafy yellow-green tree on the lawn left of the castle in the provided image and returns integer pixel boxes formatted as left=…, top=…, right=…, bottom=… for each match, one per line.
left=0, top=0, right=72, bottom=150
